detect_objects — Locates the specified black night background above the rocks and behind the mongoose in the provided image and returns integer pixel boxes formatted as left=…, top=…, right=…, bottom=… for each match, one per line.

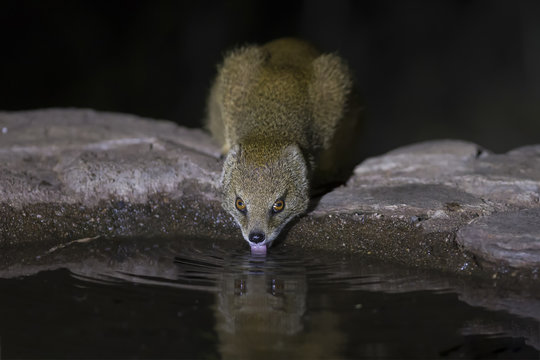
left=0, top=0, right=540, bottom=155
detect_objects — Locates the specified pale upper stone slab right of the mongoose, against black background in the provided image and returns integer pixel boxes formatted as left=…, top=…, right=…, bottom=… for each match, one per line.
left=342, top=140, right=540, bottom=212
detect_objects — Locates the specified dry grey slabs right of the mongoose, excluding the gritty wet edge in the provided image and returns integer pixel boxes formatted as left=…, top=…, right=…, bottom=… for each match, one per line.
left=313, top=140, right=540, bottom=268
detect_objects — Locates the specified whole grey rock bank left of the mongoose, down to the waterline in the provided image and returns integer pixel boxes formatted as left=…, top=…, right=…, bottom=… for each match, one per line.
left=0, top=109, right=234, bottom=250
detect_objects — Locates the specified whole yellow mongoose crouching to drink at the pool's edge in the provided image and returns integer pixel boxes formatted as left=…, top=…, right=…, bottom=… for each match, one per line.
left=207, top=39, right=356, bottom=251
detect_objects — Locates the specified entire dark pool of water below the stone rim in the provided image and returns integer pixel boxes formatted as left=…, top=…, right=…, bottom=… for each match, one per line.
left=0, top=239, right=540, bottom=360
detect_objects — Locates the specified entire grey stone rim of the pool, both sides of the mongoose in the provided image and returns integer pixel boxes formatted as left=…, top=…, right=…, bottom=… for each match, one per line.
left=0, top=109, right=540, bottom=276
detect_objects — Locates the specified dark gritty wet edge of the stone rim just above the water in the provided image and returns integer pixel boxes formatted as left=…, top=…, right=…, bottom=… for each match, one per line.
left=0, top=110, right=538, bottom=279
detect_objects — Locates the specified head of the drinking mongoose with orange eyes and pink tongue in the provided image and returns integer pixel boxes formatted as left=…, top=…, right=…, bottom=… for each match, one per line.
left=221, top=140, right=309, bottom=250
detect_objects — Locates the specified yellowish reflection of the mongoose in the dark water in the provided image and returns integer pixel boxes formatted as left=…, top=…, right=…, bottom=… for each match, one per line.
left=216, top=259, right=306, bottom=359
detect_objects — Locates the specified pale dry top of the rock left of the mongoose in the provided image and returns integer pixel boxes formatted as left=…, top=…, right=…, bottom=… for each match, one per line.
left=0, top=110, right=219, bottom=207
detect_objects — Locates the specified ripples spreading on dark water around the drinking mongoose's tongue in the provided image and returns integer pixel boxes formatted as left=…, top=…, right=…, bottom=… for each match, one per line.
left=65, top=236, right=448, bottom=292
